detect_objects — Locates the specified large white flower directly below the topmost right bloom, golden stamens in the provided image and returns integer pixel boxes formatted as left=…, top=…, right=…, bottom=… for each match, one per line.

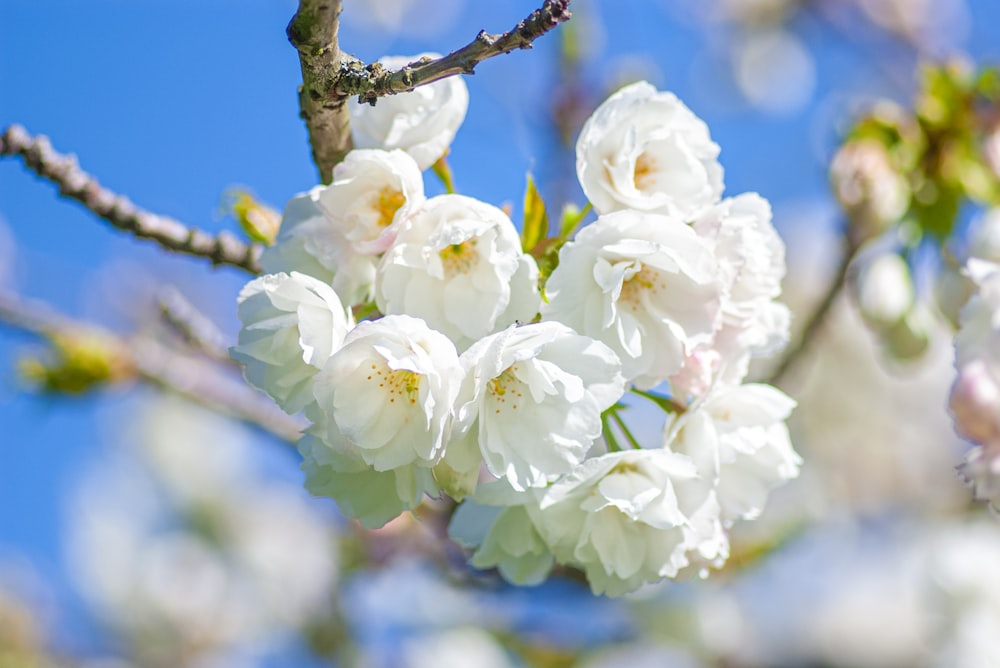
left=542, top=211, right=723, bottom=388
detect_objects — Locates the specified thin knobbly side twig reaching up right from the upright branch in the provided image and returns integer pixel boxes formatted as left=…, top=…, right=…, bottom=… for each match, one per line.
left=336, top=0, right=572, bottom=104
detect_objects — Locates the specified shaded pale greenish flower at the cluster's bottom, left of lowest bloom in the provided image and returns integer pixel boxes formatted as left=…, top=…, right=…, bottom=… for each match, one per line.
left=448, top=480, right=555, bottom=585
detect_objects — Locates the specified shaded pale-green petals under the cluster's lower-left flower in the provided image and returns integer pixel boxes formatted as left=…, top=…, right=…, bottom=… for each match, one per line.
left=298, top=435, right=438, bottom=529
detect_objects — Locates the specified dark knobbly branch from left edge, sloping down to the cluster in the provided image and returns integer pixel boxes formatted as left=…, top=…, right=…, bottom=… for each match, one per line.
left=0, top=125, right=260, bottom=274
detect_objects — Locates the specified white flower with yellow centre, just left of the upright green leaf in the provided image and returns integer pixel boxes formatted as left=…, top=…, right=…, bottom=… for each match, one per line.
left=376, top=195, right=539, bottom=348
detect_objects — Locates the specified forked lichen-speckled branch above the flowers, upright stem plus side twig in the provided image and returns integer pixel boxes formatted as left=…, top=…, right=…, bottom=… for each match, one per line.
left=286, top=0, right=572, bottom=183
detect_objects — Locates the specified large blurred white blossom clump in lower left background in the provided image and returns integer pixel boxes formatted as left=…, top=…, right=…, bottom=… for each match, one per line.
left=67, top=396, right=338, bottom=665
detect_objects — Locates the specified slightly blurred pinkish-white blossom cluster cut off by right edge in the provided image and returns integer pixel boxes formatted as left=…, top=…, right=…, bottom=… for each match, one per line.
left=949, top=258, right=1000, bottom=511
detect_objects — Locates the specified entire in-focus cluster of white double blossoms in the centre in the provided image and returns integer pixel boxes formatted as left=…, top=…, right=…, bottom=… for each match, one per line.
left=233, top=72, right=800, bottom=595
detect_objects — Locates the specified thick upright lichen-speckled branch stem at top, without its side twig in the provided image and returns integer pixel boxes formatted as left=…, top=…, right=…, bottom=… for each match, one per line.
left=285, top=0, right=353, bottom=183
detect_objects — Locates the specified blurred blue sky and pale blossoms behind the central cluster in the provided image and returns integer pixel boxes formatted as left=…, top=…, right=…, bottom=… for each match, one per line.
left=0, top=0, right=1000, bottom=668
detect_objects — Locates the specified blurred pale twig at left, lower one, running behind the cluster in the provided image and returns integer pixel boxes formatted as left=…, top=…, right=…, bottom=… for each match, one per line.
left=0, top=291, right=305, bottom=443
